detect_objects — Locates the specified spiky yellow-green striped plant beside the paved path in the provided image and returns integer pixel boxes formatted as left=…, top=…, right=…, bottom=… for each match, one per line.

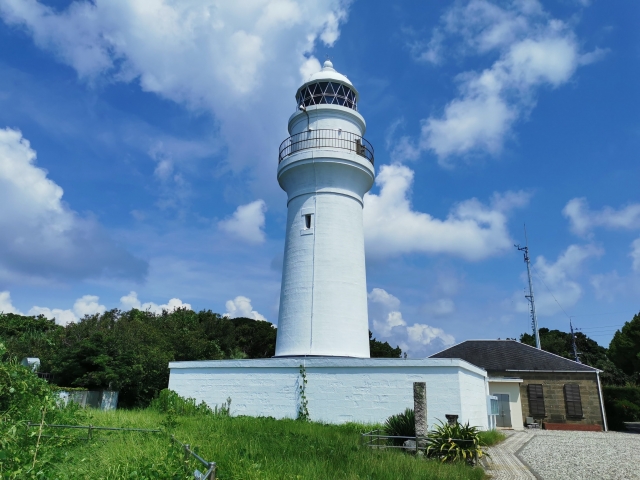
left=425, top=422, right=488, bottom=463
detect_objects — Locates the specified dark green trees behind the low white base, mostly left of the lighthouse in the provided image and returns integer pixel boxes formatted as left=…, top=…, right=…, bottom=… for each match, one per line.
left=0, top=309, right=401, bottom=408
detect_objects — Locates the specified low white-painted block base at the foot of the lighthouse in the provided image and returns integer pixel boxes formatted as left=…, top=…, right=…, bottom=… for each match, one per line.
left=169, top=357, right=488, bottom=429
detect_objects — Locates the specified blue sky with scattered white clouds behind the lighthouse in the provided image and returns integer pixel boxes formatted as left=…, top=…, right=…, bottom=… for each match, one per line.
left=0, top=0, right=640, bottom=357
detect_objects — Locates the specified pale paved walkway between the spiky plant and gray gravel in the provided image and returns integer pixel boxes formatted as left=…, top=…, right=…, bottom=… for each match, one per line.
left=484, top=431, right=537, bottom=480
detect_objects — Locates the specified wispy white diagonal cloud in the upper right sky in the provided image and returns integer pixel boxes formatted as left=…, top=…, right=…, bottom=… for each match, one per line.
left=394, top=0, right=605, bottom=167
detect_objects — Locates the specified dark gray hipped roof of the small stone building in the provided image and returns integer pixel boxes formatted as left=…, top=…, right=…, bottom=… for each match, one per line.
left=429, top=340, right=597, bottom=372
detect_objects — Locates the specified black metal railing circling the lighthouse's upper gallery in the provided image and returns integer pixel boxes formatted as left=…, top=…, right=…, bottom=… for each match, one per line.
left=278, top=128, right=373, bottom=165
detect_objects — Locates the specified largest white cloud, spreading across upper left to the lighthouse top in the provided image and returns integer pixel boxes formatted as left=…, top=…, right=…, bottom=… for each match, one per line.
left=0, top=0, right=350, bottom=197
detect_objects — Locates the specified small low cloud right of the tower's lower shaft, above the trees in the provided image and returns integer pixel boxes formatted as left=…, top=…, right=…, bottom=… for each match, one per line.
left=368, top=288, right=455, bottom=357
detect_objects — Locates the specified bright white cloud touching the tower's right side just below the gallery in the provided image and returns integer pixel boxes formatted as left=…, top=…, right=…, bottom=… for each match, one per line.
left=364, top=164, right=530, bottom=260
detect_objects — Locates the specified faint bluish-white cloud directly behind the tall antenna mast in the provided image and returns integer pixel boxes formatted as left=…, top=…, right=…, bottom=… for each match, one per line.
left=513, top=245, right=604, bottom=316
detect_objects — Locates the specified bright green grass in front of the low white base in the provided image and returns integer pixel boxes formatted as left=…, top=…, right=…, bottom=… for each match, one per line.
left=47, top=410, right=484, bottom=480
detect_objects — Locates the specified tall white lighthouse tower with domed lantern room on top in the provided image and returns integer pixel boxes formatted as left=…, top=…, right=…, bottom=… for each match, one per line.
left=276, top=61, right=374, bottom=358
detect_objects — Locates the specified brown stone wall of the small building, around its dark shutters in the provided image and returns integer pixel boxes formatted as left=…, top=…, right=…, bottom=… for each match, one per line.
left=491, top=372, right=604, bottom=427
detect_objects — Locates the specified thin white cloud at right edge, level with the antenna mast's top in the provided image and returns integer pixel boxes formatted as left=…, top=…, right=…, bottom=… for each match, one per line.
left=562, top=198, right=640, bottom=235
